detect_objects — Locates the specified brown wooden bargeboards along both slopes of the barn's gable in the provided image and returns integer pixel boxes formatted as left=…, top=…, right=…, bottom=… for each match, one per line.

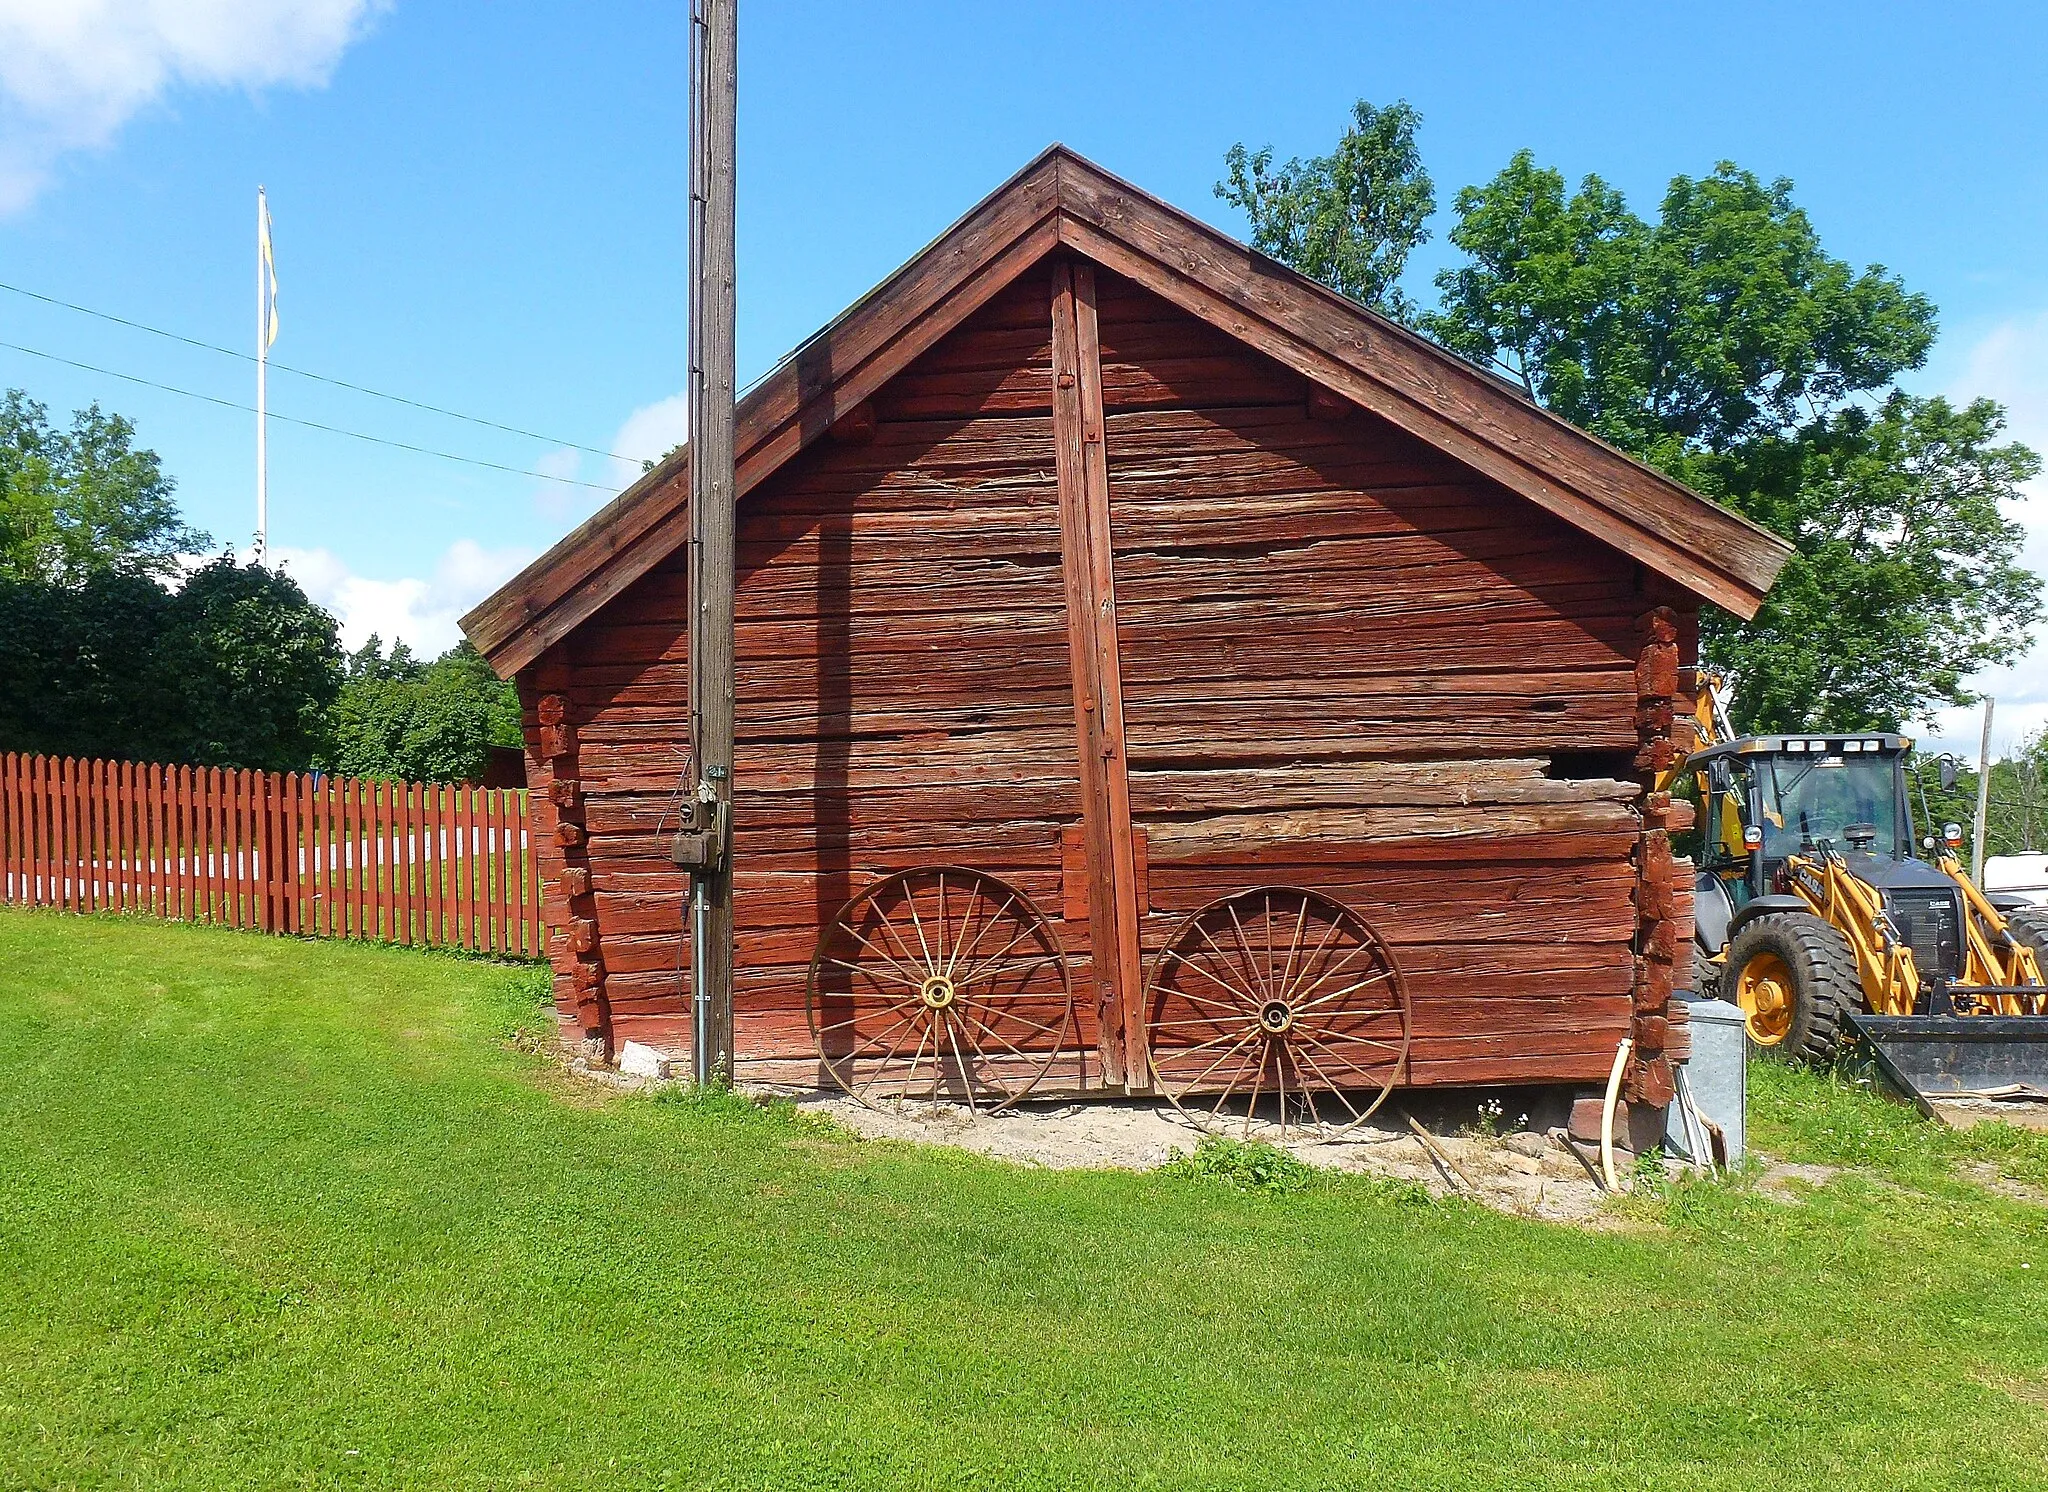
left=463, top=145, right=1790, bottom=675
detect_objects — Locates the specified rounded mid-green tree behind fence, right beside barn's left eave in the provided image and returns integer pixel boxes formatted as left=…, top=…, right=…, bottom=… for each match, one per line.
left=328, top=637, right=522, bottom=782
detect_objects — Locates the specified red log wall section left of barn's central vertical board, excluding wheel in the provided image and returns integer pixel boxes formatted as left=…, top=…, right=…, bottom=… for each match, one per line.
left=532, top=272, right=1096, bottom=1083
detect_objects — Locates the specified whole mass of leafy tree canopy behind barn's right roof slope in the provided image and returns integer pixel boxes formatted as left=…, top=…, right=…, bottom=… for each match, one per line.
left=1219, top=104, right=2040, bottom=731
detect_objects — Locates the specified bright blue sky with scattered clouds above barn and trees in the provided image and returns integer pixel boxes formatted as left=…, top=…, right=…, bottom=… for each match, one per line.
left=0, top=0, right=2048, bottom=737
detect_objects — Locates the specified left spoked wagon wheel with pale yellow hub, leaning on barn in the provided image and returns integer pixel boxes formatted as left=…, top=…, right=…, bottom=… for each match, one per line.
left=807, top=866, right=1073, bottom=1111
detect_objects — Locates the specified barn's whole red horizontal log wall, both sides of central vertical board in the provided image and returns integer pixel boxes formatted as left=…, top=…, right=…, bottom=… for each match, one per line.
left=522, top=255, right=1690, bottom=1083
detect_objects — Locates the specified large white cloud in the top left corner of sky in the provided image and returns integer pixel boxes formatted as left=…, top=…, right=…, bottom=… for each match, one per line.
left=0, top=0, right=389, bottom=213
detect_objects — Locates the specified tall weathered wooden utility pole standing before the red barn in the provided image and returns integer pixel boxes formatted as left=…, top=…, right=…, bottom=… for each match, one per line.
left=676, top=0, right=739, bottom=1083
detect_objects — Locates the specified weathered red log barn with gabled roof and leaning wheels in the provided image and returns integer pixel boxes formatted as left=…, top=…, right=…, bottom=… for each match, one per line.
left=463, top=147, right=1786, bottom=1122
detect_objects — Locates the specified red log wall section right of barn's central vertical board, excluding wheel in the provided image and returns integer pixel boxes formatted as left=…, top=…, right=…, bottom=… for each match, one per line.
left=1100, top=274, right=1642, bottom=1085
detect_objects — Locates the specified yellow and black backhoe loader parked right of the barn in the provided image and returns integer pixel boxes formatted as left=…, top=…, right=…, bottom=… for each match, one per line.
left=1667, top=677, right=2048, bottom=1107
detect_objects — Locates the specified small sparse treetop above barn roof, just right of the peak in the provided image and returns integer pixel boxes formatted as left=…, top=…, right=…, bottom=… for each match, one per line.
left=1217, top=98, right=1436, bottom=321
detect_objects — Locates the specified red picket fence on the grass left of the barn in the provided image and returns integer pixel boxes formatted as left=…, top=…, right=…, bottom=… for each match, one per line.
left=0, top=753, right=545, bottom=958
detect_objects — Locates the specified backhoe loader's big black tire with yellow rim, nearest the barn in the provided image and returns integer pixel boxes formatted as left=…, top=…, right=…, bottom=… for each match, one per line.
left=1722, top=913, right=1864, bottom=1066
